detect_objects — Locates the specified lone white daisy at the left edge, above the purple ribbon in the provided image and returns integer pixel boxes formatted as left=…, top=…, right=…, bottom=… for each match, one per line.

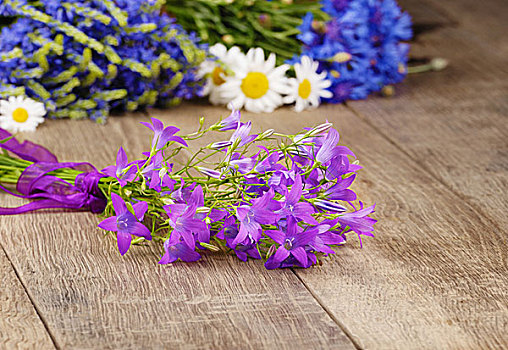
left=0, top=96, right=46, bottom=132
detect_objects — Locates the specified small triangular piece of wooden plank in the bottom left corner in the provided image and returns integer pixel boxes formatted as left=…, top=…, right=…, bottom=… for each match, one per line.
left=0, top=247, right=55, bottom=349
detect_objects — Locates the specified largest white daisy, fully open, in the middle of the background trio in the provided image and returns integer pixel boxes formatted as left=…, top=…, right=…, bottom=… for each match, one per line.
left=221, top=48, right=289, bottom=113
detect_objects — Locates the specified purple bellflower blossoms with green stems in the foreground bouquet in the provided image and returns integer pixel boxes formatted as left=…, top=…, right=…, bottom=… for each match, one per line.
left=99, top=111, right=376, bottom=269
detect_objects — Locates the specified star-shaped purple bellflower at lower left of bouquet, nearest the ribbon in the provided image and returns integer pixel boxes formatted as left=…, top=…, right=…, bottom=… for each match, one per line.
left=99, top=193, right=152, bottom=255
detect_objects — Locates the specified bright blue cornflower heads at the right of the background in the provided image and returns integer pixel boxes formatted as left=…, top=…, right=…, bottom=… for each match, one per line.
left=292, top=0, right=412, bottom=103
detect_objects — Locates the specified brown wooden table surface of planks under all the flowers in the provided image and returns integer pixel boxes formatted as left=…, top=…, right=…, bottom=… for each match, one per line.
left=0, top=0, right=508, bottom=350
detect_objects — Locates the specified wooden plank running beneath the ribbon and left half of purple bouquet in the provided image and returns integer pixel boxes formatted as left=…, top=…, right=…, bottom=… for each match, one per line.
left=0, top=113, right=354, bottom=349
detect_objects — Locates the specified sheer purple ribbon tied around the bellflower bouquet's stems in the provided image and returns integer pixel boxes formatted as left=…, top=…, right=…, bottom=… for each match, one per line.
left=0, top=129, right=106, bottom=215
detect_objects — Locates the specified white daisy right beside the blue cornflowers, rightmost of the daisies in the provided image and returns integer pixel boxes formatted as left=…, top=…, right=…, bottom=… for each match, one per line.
left=284, top=56, right=333, bottom=112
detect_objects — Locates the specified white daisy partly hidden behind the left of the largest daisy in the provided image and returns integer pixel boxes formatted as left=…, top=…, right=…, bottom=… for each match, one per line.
left=198, top=43, right=245, bottom=105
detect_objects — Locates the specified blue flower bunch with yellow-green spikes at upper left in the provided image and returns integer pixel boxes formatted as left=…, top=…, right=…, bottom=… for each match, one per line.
left=0, top=0, right=206, bottom=122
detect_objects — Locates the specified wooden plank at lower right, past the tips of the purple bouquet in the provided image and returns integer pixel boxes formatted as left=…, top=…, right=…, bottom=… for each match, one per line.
left=244, top=102, right=508, bottom=349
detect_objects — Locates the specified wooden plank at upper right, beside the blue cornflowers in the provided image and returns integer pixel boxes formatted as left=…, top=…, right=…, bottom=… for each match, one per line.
left=348, top=1, right=508, bottom=230
